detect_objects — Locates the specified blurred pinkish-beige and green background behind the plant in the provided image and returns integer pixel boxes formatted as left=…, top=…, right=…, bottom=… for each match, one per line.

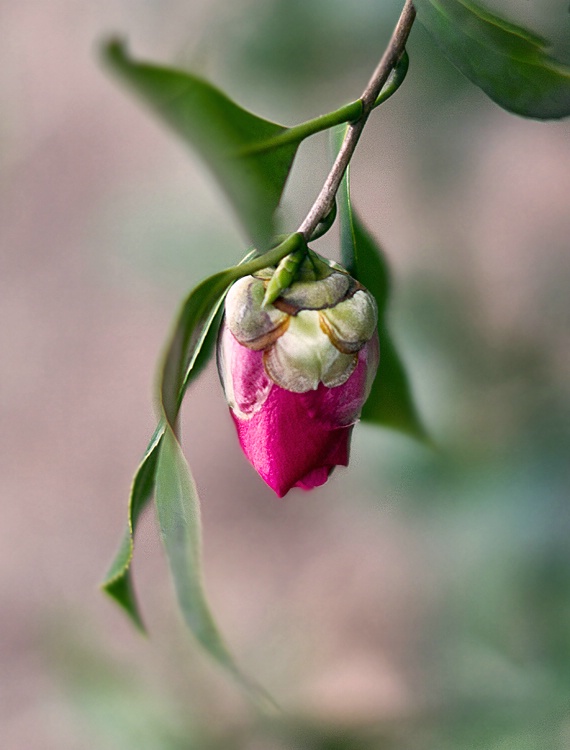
left=0, top=0, right=570, bottom=750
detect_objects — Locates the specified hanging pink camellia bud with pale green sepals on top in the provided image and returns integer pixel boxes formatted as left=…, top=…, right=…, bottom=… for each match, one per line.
left=218, top=252, right=379, bottom=497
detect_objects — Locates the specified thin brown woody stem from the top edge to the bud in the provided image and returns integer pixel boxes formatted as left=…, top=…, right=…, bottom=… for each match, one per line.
left=297, top=0, right=416, bottom=240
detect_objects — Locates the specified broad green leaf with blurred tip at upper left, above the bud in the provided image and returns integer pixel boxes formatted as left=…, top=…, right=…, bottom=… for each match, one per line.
left=104, top=40, right=302, bottom=248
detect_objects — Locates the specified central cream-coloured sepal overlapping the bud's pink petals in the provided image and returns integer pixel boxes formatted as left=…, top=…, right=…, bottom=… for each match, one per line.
left=264, top=310, right=356, bottom=393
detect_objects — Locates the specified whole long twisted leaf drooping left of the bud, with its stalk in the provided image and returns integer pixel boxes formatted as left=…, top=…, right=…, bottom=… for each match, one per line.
left=155, top=234, right=302, bottom=705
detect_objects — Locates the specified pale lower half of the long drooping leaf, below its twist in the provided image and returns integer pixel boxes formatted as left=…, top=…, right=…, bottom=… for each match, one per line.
left=155, top=426, right=272, bottom=705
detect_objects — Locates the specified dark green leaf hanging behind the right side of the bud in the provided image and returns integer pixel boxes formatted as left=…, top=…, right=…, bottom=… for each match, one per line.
left=333, top=128, right=428, bottom=442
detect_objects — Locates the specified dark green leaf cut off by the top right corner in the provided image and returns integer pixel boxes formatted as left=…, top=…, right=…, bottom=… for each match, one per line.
left=414, top=0, right=570, bottom=119
